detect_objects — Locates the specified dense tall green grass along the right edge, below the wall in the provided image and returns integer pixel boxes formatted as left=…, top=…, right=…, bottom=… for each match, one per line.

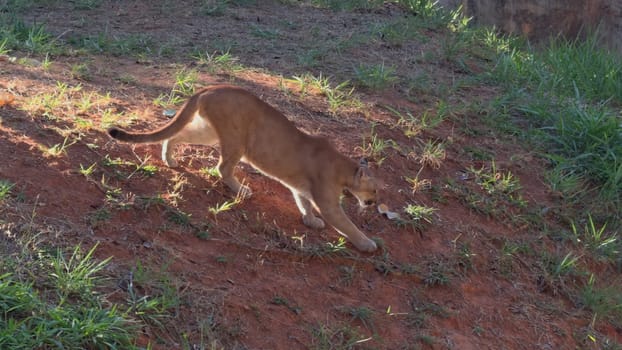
left=491, top=35, right=622, bottom=216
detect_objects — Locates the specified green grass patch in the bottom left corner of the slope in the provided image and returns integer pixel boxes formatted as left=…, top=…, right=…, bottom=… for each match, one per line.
left=0, top=247, right=137, bottom=349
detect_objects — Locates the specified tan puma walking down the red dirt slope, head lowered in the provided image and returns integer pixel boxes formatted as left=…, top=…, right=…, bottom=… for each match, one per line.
left=108, top=85, right=377, bottom=252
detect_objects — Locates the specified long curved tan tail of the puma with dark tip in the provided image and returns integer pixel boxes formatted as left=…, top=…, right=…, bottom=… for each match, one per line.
left=108, top=93, right=201, bottom=143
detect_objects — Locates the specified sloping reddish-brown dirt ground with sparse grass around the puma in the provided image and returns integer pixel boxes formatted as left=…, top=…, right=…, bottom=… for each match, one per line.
left=0, top=1, right=620, bottom=349
